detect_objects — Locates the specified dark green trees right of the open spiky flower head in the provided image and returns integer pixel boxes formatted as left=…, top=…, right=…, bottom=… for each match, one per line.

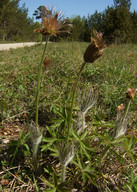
left=70, top=0, right=137, bottom=43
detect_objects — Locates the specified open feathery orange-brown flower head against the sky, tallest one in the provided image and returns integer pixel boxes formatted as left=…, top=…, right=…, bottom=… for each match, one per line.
left=34, top=6, right=71, bottom=36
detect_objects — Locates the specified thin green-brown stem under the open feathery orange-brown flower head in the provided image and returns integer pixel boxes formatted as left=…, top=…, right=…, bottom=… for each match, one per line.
left=35, top=36, right=50, bottom=125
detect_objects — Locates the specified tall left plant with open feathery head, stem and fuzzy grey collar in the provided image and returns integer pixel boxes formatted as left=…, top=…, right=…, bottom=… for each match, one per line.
left=29, top=6, right=70, bottom=174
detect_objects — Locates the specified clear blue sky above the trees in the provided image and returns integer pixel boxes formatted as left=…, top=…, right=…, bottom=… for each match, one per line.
left=20, top=0, right=137, bottom=18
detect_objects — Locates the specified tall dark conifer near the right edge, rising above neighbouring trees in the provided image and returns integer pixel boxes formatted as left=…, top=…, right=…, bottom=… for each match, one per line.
left=104, top=0, right=132, bottom=43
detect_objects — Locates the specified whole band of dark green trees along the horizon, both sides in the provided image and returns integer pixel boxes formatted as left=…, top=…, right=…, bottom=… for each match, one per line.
left=0, top=0, right=137, bottom=43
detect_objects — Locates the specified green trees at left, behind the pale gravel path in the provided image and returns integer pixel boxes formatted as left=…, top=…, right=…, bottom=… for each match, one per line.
left=0, top=0, right=40, bottom=41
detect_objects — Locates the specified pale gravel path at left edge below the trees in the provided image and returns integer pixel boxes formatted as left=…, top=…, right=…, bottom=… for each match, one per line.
left=0, top=42, right=38, bottom=51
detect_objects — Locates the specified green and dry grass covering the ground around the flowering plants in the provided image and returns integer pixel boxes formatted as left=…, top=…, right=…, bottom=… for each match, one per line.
left=0, top=42, right=137, bottom=191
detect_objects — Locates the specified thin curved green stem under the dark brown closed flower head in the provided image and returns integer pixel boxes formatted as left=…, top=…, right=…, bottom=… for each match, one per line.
left=67, top=62, right=86, bottom=141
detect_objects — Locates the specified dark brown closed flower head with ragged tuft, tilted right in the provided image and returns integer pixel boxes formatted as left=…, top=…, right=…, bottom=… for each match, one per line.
left=84, top=30, right=106, bottom=63
